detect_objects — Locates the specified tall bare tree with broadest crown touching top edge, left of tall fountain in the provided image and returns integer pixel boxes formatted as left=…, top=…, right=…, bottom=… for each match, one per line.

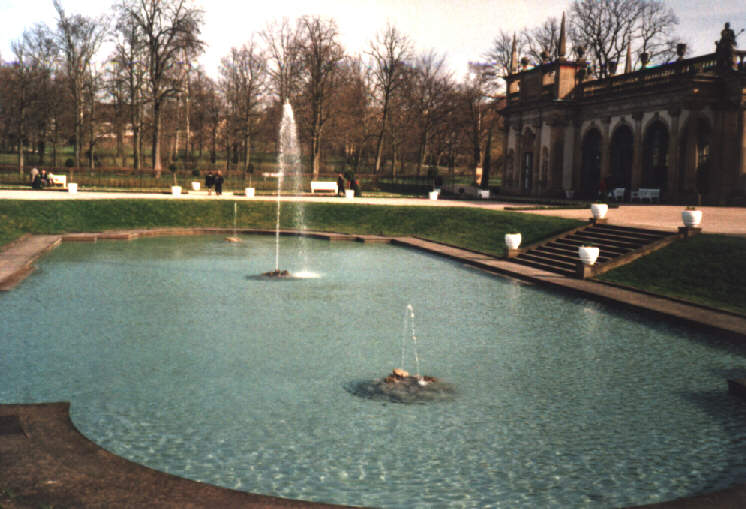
left=120, top=0, right=204, bottom=176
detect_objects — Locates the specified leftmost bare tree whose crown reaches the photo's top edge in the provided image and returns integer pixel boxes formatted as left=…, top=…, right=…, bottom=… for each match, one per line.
left=54, top=0, right=108, bottom=179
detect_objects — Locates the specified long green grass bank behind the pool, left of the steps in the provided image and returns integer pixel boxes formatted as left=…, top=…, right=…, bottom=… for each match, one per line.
left=0, top=199, right=581, bottom=256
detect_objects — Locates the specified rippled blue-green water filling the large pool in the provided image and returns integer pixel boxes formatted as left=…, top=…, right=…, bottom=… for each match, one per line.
left=0, top=236, right=746, bottom=508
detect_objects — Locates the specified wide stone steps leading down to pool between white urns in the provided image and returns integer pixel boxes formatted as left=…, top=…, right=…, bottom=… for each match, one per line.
left=509, top=224, right=678, bottom=277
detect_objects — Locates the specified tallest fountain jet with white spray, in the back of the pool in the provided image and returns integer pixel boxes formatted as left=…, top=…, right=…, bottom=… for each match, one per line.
left=262, top=101, right=306, bottom=278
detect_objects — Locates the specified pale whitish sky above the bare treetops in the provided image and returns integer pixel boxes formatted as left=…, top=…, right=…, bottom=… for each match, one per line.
left=0, top=0, right=746, bottom=78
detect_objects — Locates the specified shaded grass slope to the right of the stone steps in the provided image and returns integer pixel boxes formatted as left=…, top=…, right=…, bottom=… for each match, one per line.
left=598, top=235, right=746, bottom=315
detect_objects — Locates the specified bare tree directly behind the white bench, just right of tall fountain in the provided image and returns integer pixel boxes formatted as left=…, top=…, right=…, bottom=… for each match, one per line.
left=300, top=16, right=344, bottom=178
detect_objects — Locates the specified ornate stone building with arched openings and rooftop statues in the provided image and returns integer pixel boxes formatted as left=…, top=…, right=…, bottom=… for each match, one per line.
left=502, top=17, right=746, bottom=203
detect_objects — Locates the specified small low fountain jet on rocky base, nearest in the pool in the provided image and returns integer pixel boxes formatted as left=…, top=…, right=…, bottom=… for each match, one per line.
left=350, top=304, right=453, bottom=403
